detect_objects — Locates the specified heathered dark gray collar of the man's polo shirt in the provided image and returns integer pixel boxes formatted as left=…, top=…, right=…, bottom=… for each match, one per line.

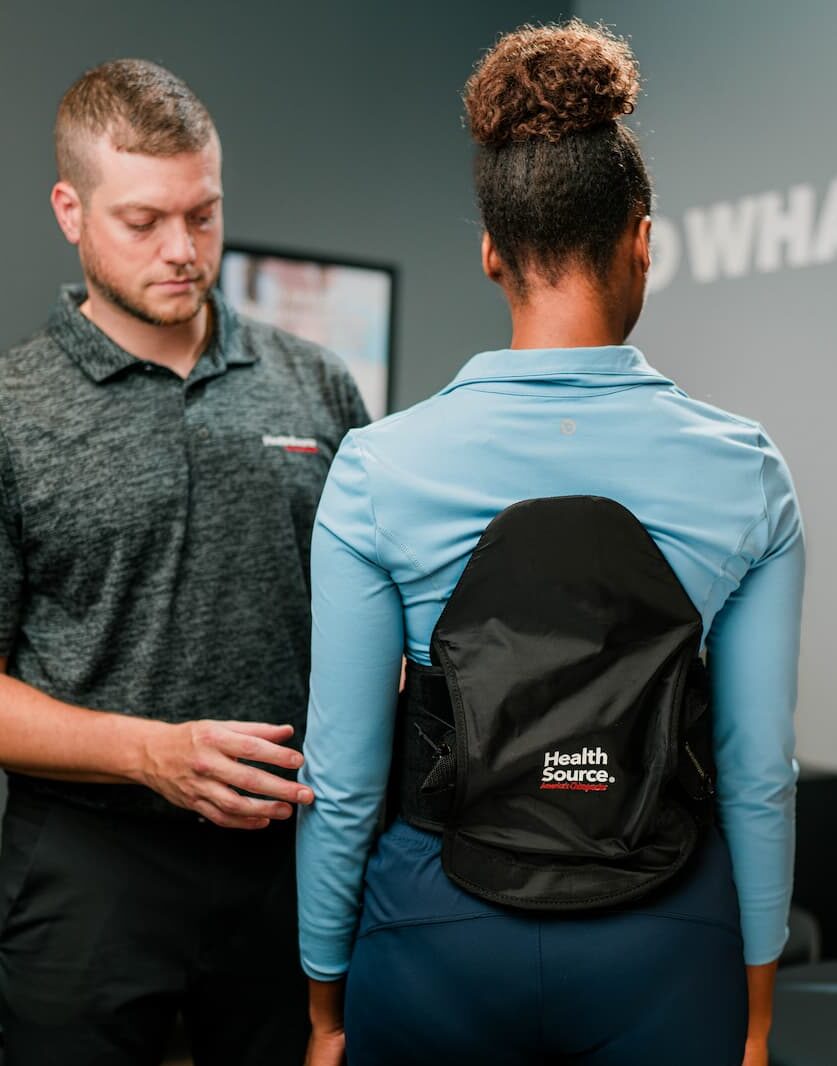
left=47, top=285, right=259, bottom=382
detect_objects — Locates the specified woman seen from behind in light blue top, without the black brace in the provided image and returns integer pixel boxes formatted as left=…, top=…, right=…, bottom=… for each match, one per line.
left=299, top=20, right=803, bottom=1066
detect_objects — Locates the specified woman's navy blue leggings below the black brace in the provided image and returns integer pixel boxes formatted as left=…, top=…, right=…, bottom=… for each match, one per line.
left=345, top=823, right=746, bottom=1066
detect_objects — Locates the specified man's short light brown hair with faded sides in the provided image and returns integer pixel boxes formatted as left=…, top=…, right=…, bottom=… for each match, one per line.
left=55, top=60, right=215, bottom=197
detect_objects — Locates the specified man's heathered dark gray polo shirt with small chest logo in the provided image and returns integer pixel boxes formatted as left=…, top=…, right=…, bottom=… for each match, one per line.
left=0, top=287, right=368, bottom=810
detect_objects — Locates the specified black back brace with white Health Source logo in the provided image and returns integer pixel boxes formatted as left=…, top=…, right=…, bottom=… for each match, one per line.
left=390, top=496, right=713, bottom=910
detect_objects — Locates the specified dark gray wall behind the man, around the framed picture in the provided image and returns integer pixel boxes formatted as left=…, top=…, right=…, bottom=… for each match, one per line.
left=0, top=0, right=557, bottom=406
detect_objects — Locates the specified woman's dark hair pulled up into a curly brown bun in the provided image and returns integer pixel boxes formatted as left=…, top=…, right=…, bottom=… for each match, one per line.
left=464, top=18, right=651, bottom=294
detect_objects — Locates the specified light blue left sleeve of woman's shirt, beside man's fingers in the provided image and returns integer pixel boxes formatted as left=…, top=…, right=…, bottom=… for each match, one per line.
left=297, top=434, right=404, bottom=982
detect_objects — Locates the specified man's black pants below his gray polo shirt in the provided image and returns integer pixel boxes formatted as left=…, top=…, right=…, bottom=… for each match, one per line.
left=0, top=790, right=308, bottom=1066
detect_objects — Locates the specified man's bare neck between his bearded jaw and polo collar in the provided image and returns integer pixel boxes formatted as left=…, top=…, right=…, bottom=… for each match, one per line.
left=79, top=289, right=213, bottom=378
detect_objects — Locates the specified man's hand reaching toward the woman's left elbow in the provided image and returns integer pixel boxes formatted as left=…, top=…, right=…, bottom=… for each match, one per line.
left=135, top=720, right=313, bottom=829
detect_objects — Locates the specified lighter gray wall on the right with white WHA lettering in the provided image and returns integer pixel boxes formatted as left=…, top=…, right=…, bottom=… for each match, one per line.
left=577, top=0, right=837, bottom=766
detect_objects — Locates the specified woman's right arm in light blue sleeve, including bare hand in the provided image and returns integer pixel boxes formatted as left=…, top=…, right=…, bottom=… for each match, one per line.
left=707, top=432, right=805, bottom=1066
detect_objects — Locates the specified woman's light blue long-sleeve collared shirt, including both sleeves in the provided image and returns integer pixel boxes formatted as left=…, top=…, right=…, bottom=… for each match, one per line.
left=297, top=346, right=804, bottom=981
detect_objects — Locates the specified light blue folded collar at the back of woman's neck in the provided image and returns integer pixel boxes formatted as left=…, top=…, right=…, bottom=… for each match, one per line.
left=445, top=344, right=672, bottom=391
